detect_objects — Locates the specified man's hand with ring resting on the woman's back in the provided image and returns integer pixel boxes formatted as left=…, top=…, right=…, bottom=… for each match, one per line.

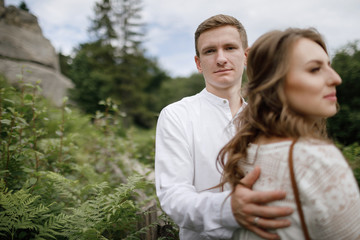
left=231, top=167, right=294, bottom=239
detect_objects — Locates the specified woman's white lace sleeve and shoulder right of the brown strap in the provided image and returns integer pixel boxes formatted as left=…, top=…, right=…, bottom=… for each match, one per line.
left=294, top=144, right=360, bottom=240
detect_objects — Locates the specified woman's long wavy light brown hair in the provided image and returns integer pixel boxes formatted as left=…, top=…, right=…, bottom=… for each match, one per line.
left=217, top=28, right=327, bottom=189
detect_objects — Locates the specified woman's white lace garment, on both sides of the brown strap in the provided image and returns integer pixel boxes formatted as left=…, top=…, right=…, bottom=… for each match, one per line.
left=233, top=140, right=360, bottom=240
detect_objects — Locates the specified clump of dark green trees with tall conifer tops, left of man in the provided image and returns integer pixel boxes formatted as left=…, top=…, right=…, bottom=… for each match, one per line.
left=68, top=0, right=169, bottom=128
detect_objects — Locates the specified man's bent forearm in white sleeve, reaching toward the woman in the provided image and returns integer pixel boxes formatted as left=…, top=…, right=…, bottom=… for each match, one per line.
left=158, top=185, right=239, bottom=238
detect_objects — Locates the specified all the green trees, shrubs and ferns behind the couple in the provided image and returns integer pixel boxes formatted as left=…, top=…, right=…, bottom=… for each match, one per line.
left=0, top=0, right=360, bottom=239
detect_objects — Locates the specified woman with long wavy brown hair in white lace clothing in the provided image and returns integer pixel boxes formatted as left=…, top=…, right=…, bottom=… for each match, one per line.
left=218, top=29, right=360, bottom=240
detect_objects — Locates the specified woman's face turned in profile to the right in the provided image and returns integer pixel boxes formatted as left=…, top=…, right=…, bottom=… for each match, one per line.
left=285, top=38, right=341, bottom=119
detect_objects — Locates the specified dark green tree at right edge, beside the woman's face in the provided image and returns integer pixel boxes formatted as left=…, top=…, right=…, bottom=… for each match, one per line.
left=329, top=41, right=360, bottom=145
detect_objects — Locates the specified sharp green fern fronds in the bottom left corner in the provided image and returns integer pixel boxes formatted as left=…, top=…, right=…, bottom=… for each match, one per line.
left=0, top=172, right=151, bottom=240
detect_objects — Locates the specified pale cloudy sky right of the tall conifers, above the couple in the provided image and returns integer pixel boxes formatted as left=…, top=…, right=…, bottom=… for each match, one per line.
left=145, top=0, right=360, bottom=75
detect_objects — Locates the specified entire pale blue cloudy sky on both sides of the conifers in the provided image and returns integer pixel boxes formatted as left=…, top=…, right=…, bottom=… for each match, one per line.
left=5, top=0, right=360, bottom=77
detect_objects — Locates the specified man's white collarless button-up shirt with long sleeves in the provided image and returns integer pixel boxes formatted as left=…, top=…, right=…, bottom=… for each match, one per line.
left=155, top=89, right=245, bottom=240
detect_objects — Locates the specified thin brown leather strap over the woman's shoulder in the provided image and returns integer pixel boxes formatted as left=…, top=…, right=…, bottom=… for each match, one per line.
left=289, top=140, right=310, bottom=240
